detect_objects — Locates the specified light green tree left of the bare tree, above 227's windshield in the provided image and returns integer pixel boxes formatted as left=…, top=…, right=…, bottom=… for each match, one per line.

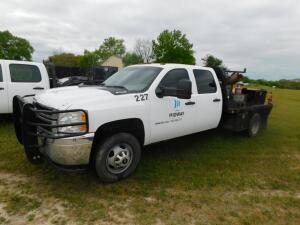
left=96, top=37, right=126, bottom=61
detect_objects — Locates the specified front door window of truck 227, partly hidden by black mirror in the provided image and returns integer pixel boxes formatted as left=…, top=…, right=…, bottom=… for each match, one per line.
left=159, top=69, right=189, bottom=89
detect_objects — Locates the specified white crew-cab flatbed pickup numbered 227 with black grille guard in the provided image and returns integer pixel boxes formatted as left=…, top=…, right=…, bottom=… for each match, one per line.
left=13, top=64, right=272, bottom=182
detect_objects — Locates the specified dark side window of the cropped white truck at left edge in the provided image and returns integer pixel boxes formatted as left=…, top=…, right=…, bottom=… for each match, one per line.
left=9, top=64, right=42, bottom=83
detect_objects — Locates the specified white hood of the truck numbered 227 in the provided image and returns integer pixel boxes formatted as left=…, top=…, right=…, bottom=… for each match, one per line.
left=34, top=86, right=115, bottom=110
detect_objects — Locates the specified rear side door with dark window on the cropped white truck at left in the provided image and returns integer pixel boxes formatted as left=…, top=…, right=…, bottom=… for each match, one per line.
left=7, top=62, right=47, bottom=112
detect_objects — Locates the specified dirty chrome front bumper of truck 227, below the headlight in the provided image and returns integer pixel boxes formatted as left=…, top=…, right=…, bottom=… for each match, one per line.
left=39, top=133, right=94, bottom=167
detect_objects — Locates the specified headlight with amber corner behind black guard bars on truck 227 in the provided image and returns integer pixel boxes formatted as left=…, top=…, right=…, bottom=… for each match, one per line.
left=57, top=111, right=87, bottom=133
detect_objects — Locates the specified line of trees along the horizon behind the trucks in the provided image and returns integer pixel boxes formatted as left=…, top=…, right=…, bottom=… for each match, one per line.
left=0, top=30, right=300, bottom=89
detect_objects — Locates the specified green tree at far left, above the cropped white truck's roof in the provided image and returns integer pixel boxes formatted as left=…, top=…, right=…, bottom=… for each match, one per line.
left=0, top=31, right=34, bottom=61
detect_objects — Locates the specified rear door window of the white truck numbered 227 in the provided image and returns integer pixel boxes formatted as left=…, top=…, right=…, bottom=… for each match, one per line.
left=193, top=69, right=217, bottom=94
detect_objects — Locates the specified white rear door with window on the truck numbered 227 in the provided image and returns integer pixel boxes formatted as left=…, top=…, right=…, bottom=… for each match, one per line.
left=193, top=69, right=222, bottom=132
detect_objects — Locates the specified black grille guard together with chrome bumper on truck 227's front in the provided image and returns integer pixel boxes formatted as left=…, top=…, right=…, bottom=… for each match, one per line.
left=13, top=96, right=94, bottom=170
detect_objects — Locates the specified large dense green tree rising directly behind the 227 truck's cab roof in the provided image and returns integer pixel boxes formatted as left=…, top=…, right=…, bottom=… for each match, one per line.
left=152, top=30, right=195, bottom=65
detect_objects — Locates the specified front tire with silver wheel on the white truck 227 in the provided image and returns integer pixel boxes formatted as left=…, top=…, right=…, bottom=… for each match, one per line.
left=95, top=133, right=141, bottom=183
